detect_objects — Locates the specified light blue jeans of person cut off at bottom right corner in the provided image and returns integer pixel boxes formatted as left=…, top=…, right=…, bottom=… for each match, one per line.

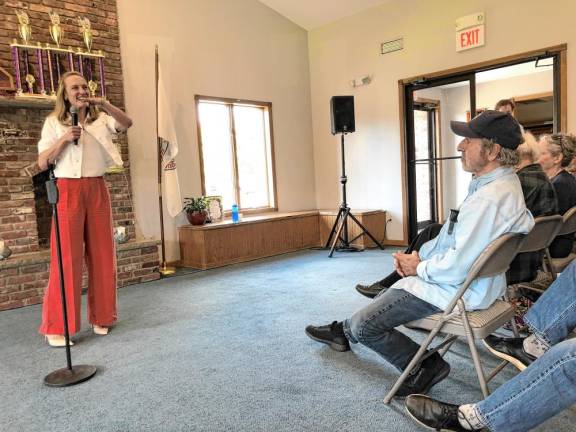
left=476, top=262, right=576, bottom=432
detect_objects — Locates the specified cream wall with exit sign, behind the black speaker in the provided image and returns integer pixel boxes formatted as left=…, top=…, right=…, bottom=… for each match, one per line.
left=309, top=0, right=576, bottom=243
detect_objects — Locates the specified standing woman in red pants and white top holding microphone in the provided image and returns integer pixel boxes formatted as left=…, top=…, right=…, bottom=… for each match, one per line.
left=38, top=72, right=132, bottom=347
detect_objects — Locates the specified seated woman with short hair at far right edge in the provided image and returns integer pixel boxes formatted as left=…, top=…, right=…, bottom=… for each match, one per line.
left=538, top=133, right=576, bottom=258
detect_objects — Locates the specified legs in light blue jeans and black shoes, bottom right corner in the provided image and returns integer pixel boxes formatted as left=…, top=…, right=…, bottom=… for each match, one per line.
left=406, top=262, right=576, bottom=432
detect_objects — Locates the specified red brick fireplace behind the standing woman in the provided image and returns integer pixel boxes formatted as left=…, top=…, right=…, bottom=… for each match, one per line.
left=0, top=0, right=160, bottom=311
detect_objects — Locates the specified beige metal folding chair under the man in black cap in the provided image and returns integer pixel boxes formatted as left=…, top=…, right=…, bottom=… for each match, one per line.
left=384, top=233, right=526, bottom=404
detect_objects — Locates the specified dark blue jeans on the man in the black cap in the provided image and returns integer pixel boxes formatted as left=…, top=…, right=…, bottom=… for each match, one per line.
left=344, top=289, right=442, bottom=371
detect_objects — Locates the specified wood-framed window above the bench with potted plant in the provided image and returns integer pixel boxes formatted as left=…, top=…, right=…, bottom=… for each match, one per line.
left=196, top=96, right=276, bottom=211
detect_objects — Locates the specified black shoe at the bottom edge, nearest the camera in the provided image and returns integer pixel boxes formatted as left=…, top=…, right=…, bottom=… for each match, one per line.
left=405, top=395, right=466, bottom=432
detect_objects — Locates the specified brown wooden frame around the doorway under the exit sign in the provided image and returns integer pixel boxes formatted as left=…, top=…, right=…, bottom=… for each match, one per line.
left=396, top=44, right=568, bottom=245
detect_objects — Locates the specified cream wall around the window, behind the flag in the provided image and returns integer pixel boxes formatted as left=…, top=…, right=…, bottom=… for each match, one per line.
left=118, top=0, right=316, bottom=261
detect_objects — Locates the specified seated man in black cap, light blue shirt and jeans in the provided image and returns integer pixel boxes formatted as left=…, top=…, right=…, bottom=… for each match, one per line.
left=306, top=111, right=534, bottom=396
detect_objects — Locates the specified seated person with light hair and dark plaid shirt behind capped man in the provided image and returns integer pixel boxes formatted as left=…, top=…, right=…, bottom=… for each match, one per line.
left=356, top=133, right=558, bottom=298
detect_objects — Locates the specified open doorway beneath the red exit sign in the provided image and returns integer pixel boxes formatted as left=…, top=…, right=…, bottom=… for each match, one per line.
left=399, top=45, right=566, bottom=243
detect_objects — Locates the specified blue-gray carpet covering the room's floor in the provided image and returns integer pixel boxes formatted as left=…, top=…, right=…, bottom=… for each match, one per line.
left=0, top=250, right=576, bottom=432
